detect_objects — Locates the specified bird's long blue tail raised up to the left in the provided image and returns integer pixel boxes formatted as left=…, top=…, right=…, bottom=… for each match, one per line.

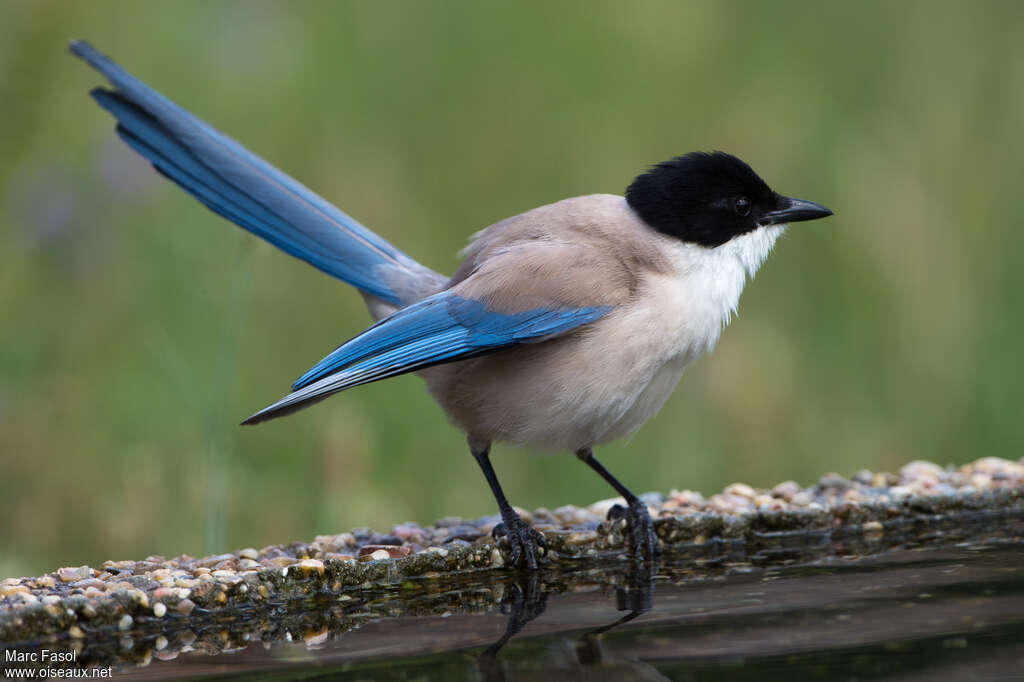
left=71, top=41, right=445, bottom=306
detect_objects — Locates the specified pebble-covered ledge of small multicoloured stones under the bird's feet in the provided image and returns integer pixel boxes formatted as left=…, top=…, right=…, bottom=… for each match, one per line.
left=0, top=450, right=1024, bottom=644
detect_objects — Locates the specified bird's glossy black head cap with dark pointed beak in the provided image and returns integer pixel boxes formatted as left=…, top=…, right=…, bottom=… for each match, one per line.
left=626, top=152, right=831, bottom=247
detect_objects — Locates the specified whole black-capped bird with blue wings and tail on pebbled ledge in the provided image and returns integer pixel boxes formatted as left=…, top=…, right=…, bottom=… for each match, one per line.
left=71, top=41, right=833, bottom=570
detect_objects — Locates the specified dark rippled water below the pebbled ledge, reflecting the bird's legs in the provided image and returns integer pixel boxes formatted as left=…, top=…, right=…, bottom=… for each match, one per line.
left=116, top=540, right=1024, bottom=682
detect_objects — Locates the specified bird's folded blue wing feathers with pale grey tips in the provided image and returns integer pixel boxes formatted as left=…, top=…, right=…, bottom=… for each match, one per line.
left=243, top=291, right=611, bottom=424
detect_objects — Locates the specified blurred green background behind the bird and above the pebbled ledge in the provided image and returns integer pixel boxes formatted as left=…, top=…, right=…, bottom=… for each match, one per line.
left=0, top=0, right=1024, bottom=577
